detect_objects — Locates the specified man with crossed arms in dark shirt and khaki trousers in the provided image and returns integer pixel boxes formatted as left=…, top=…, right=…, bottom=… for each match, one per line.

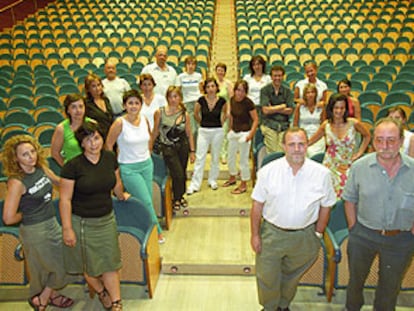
left=260, top=66, right=293, bottom=153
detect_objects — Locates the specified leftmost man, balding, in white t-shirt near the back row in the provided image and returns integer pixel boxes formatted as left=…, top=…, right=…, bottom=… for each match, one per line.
left=102, top=60, right=131, bottom=117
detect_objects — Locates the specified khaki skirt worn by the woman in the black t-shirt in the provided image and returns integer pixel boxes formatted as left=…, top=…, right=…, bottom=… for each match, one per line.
left=63, top=211, right=122, bottom=277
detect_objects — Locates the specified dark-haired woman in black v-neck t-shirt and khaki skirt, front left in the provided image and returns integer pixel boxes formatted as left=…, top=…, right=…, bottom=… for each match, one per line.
left=59, top=122, right=129, bottom=311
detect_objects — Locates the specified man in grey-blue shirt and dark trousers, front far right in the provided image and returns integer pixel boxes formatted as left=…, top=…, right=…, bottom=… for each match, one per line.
left=343, top=118, right=414, bottom=311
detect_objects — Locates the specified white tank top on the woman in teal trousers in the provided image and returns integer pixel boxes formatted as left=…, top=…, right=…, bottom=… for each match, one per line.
left=116, top=116, right=150, bottom=163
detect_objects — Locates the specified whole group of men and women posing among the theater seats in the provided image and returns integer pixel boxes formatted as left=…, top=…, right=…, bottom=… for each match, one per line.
left=3, top=47, right=414, bottom=311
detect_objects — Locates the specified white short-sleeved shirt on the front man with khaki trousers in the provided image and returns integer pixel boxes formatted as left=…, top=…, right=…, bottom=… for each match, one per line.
left=252, top=157, right=336, bottom=229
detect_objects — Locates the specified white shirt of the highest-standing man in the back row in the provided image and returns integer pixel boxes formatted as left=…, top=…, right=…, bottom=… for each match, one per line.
left=138, top=62, right=177, bottom=97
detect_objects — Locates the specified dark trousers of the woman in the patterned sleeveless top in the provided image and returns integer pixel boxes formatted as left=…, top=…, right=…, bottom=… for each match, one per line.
left=161, top=137, right=189, bottom=201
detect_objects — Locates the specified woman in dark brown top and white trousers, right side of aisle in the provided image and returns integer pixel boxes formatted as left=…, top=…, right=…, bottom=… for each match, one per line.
left=223, top=80, right=259, bottom=194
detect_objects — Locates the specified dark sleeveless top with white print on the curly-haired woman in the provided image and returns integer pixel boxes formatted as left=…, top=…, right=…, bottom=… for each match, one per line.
left=19, top=167, right=55, bottom=225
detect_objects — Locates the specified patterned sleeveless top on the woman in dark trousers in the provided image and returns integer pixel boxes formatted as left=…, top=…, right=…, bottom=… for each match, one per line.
left=159, top=107, right=187, bottom=146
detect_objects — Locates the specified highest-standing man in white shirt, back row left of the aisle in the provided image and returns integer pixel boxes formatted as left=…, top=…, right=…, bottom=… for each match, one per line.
left=141, top=46, right=177, bottom=97
